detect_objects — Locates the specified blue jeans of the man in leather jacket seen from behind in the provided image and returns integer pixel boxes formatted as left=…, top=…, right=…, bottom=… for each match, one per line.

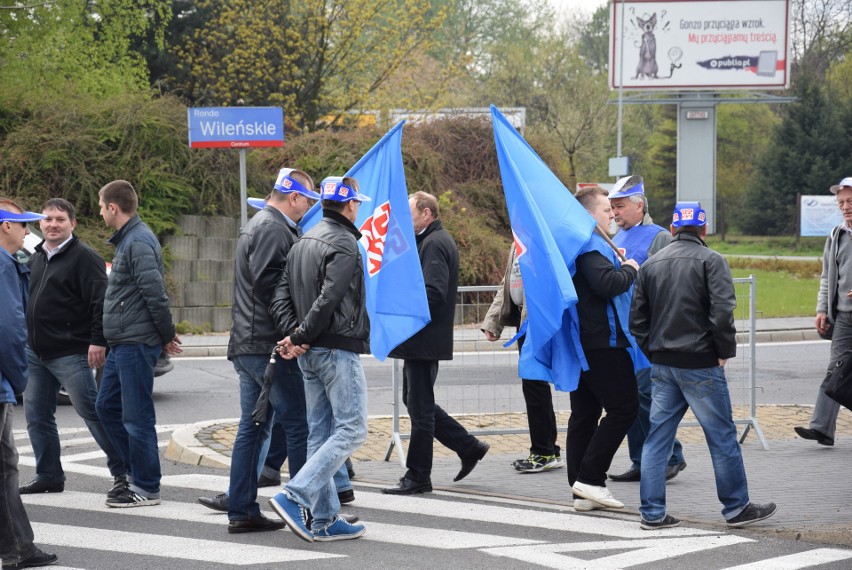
left=639, top=364, right=748, bottom=522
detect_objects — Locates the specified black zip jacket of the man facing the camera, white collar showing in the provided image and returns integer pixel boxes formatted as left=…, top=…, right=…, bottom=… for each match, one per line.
left=27, top=236, right=107, bottom=360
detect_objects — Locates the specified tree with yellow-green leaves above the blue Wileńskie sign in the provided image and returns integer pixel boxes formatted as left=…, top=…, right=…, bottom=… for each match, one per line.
left=174, top=0, right=443, bottom=130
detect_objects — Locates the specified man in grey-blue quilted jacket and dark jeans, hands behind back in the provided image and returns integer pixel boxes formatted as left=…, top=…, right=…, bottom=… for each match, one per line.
left=96, top=180, right=181, bottom=508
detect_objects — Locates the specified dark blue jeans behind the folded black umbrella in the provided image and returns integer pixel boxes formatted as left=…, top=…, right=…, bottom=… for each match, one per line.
left=228, top=354, right=308, bottom=521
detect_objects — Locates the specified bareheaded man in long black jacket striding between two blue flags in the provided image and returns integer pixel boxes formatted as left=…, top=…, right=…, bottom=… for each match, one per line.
left=382, top=192, right=488, bottom=495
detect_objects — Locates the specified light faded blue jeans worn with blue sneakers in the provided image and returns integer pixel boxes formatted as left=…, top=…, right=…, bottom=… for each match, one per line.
left=284, top=347, right=367, bottom=529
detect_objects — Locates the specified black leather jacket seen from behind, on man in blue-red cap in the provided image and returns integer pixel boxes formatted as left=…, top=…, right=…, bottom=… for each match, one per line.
left=630, top=233, right=737, bottom=368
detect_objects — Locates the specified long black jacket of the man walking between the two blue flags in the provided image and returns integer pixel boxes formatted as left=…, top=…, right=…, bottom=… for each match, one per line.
left=390, top=220, right=459, bottom=360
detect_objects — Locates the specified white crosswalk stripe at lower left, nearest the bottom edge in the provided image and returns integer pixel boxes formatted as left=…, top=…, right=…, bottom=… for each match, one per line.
left=32, top=520, right=343, bottom=566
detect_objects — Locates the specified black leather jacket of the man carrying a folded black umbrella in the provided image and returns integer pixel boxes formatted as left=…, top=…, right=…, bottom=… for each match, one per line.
left=228, top=206, right=299, bottom=358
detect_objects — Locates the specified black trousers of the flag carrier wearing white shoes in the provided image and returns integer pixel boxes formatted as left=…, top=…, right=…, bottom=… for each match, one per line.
left=565, top=348, right=639, bottom=487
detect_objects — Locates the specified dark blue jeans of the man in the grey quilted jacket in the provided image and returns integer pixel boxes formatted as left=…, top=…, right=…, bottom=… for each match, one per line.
left=95, top=344, right=163, bottom=499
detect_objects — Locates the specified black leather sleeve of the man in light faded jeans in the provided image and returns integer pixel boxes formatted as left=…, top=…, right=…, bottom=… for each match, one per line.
left=290, top=241, right=361, bottom=344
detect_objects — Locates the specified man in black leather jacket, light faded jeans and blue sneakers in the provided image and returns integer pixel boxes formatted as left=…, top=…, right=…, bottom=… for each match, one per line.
left=269, top=177, right=370, bottom=542
